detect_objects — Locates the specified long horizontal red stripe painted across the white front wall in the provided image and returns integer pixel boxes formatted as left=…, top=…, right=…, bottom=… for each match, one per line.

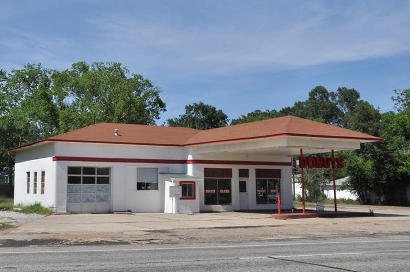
left=53, top=156, right=291, bottom=166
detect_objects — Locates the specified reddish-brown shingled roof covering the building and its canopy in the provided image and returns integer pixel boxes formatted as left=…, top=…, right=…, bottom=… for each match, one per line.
left=8, top=116, right=382, bottom=152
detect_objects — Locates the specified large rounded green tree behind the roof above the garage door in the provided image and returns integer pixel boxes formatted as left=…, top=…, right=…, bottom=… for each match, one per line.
left=53, top=62, right=165, bottom=131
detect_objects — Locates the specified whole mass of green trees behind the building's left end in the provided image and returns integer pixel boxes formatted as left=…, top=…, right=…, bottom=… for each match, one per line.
left=0, top=62, right=165, bottom=176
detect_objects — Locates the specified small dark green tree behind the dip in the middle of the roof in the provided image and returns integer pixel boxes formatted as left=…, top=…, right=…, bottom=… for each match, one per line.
left=167, top=102, right=228, bottom=129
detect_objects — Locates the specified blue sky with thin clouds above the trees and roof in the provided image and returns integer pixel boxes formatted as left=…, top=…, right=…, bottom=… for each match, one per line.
left=0, top=0, right=410, bottom=124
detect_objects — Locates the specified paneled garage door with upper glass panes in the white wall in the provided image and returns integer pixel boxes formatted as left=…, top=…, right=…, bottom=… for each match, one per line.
left=67, top=167, right=111, bottom=213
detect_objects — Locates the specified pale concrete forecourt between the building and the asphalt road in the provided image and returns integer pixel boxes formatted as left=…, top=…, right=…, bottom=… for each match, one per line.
left=0, top=205, right=410, bottom=244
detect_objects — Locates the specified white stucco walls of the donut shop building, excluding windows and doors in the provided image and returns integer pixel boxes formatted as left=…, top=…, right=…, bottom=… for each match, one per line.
left=15, top=139, right=302, bottom=212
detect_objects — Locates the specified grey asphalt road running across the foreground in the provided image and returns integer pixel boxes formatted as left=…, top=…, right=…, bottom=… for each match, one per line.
left=0, top=236, right=410, bottom=272
